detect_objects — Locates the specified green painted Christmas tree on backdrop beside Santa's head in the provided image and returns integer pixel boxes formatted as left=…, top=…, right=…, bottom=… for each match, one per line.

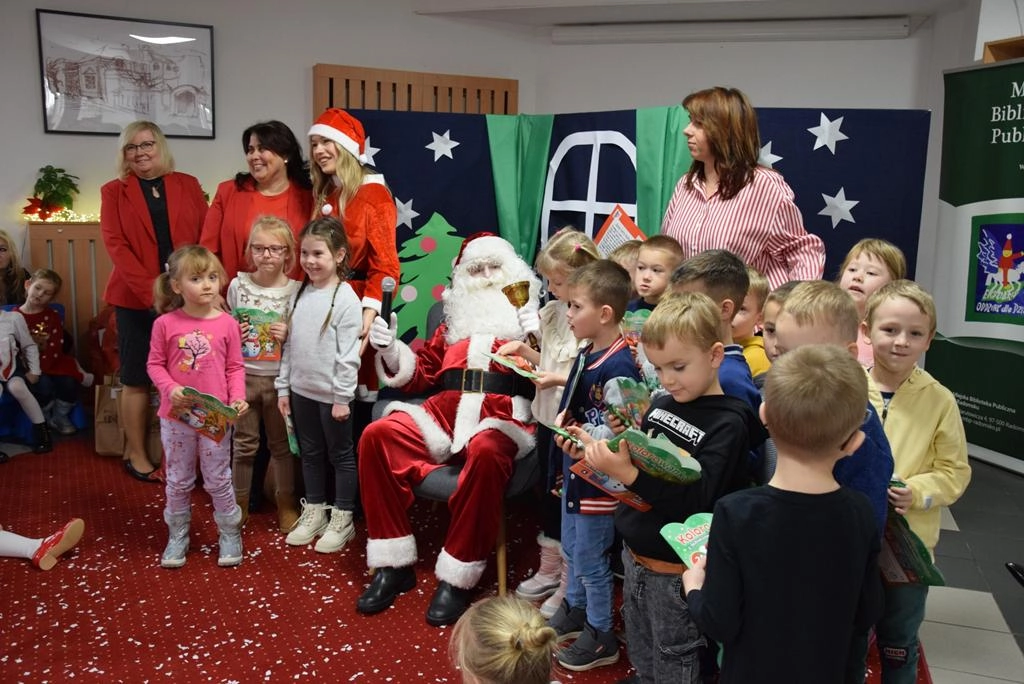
left=394, top=213, right=463, bottom=340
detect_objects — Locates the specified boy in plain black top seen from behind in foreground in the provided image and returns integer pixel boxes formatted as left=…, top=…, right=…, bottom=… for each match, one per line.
left=683, top=345, right=881, bottom=684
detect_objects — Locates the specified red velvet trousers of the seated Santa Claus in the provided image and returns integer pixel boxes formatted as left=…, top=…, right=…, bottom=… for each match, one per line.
left=359, top=412, right=517, bottom=563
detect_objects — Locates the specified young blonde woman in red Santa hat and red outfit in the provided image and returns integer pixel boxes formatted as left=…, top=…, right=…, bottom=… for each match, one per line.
left=309, top=109, right=398, bottom=421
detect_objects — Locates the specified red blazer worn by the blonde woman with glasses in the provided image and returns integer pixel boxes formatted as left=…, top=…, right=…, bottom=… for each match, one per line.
left=99, top=172, right=207, bottom=309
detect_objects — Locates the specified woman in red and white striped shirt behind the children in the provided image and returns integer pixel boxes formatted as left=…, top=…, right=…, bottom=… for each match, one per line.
left=662, top=87, right=825, bottom=290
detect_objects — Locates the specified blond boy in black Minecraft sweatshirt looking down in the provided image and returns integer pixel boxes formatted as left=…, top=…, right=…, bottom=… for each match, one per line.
left=586, top=293, right=764, bottom=684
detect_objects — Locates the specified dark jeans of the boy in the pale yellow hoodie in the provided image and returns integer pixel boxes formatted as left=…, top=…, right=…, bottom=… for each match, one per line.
left=874, top=585, right=928, bottom=684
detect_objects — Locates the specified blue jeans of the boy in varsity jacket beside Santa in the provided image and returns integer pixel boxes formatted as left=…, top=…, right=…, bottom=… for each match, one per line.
left=562, top=512, right=615, bottom=632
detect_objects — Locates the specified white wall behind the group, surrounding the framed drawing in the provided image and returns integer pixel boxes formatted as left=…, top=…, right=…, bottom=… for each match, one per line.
left=0, top=0, right=994, bottom=285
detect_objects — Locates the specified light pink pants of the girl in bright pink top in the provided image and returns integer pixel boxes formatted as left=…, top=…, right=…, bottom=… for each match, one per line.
left=160, top=418, right=236, bottom=514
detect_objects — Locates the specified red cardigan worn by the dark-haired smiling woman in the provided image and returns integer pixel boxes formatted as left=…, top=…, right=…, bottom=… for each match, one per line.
left=200, top=179, right=313, bottom=282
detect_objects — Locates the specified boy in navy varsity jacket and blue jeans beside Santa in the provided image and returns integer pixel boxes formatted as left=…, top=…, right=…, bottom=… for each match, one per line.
left=548, top=260, right=640, bottom=671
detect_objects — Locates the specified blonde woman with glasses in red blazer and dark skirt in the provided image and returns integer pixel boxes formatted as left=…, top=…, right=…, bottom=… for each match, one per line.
left=99, top=121, right=207, bottom=482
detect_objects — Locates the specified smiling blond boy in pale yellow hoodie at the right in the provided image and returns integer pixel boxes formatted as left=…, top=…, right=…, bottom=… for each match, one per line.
left=861, top=280, right=971, bottom=684
